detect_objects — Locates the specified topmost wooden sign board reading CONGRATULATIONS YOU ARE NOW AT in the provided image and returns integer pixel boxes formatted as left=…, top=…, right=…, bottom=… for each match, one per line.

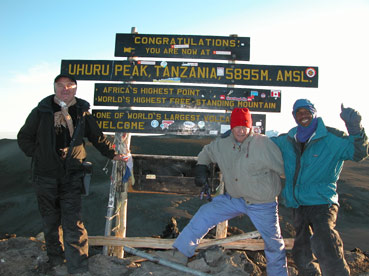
left=115, top=34, right=250, bottom=61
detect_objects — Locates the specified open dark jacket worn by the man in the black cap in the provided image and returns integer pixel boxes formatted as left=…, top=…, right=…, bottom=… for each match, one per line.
left=17, top=95, right=115, bottom=177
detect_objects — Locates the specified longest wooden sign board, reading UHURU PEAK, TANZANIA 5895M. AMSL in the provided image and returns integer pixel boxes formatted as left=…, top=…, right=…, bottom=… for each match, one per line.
left=61, top=60, right=318, bottom=87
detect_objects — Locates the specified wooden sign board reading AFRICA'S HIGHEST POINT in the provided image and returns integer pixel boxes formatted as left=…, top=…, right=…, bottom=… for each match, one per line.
left=94, top=83, right=281, bottom=112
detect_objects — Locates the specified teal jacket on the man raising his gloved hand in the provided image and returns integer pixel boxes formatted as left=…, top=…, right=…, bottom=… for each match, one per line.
left=271, top=118, right=368, bottom=208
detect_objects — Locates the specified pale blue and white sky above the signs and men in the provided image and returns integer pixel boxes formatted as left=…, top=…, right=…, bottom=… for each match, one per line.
left=0, top=0, right=369, bottom=138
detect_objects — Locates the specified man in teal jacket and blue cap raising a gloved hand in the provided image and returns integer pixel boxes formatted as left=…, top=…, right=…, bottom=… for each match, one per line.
left=272, top=99, right=368, bottom=276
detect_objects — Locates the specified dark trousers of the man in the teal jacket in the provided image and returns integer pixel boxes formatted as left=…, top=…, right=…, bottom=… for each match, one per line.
left=292, top=204, right=350, bottom=276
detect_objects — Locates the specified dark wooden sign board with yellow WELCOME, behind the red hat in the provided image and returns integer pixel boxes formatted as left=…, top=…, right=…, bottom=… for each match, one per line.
left=92, top=109, right=265, bottom=136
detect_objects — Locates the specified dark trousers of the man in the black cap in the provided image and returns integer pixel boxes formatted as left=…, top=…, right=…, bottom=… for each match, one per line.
left=35, top=173, right=88, bottom=273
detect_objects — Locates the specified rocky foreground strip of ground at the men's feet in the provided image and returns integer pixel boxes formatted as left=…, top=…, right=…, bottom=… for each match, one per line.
left=0, top=231, right=369, bottom=276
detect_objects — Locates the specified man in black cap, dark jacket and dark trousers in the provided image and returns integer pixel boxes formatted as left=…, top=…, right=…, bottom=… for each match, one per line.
left=18, top=75, right=124, bottom=275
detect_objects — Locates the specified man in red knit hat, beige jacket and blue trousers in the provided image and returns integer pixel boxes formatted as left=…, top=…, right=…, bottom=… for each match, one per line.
left=173, top=108, right=287, bottom=276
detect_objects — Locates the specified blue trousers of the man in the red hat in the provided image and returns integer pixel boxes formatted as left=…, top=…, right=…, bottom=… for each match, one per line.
left=173, top=194, right=287, bottom=276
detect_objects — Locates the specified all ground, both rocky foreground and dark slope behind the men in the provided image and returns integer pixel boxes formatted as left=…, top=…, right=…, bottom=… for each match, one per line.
left=0, top=139, right=369, bottom=276
